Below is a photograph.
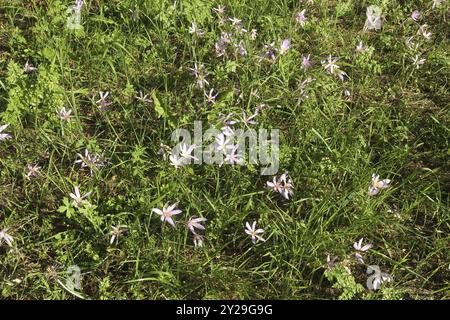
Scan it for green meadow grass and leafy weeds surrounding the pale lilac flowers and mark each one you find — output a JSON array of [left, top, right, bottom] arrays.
[[0, 0, 450, 299]]
